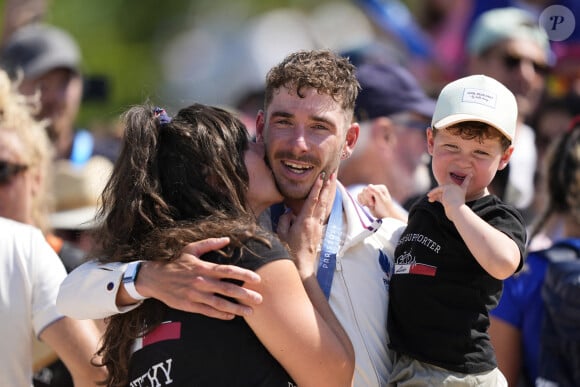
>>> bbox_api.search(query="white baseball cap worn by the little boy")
[431,75,518,142]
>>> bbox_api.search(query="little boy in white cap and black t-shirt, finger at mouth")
[361,75,526,387]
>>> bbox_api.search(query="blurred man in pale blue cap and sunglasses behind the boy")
[466,7,552,221]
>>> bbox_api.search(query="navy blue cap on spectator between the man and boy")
[355,61,435,120]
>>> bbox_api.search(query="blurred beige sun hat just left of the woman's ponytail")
[50,156,113,230]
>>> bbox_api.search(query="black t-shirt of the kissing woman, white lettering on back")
[129,238,295,387]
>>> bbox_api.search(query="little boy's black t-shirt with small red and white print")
[388,195,526,373]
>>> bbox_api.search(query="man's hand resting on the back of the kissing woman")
[136,238,262,320]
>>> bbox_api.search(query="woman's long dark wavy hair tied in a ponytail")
[91,104,268,386]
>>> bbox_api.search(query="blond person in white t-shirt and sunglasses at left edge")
[0,71,106,386]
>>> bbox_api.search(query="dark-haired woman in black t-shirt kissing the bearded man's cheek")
[93,104,354,387]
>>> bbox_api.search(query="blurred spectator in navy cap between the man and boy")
[339,61,435,212]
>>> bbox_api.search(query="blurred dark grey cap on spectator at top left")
[0,23,81,78]
